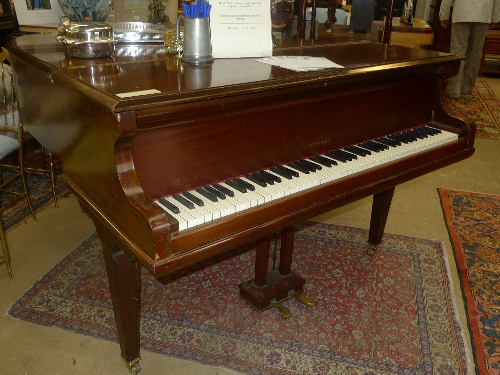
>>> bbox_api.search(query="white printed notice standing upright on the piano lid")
[210,0,273,58]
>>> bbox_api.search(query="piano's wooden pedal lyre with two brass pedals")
[238,228,314,319]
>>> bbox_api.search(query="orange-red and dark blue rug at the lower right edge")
[438,189,500,375]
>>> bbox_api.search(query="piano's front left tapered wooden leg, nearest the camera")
[87,214,141,374]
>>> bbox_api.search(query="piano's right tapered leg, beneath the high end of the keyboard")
[368,188,394,256]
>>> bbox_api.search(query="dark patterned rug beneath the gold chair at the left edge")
[1,171,69,232]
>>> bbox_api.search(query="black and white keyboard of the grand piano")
[154,126,458,231]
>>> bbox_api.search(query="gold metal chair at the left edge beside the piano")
[0,48,57,280]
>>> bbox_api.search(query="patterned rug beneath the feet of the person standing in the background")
[448,79,500,139]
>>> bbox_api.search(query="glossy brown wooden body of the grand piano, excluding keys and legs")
[8,35,474,277]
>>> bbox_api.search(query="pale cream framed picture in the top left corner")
[14,0,64,27]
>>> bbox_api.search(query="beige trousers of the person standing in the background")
[446,22,489,98]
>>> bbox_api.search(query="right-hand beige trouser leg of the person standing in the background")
[460,22,489,95]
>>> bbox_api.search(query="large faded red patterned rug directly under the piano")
[9,223,473,375]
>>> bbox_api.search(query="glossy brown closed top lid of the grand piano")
[13,34,456,101]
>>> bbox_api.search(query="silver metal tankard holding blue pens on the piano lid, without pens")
[176,16,214,64]
